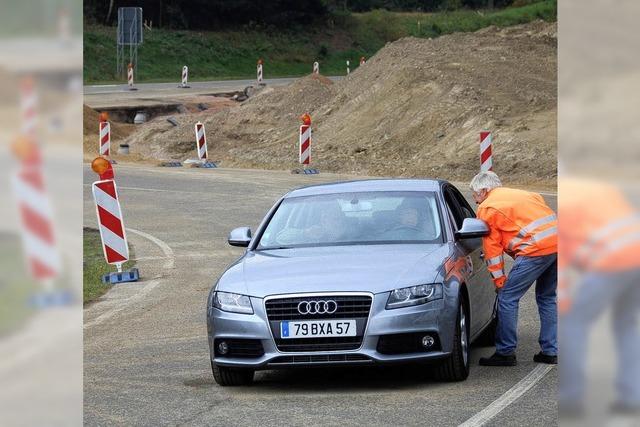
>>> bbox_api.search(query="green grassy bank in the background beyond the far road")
[84,0,557,84]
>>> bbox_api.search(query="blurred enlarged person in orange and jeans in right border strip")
[558,178,640,414]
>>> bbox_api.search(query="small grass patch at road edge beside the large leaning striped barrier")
[82,227,135,304]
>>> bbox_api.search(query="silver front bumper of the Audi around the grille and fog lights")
[207,293,457,370]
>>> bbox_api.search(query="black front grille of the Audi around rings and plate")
[265,294,372,352]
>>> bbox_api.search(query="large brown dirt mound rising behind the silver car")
[129,21,557,185]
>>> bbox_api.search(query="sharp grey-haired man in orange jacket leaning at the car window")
[470,171,558,366]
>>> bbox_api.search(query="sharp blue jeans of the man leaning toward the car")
[496,254,558,356]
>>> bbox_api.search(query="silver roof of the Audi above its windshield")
[285,179,446,198]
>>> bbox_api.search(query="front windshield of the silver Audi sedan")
[257,191,442,250]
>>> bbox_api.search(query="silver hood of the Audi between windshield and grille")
[217,244,449,298]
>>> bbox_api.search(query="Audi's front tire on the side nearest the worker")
[435,297,469,382]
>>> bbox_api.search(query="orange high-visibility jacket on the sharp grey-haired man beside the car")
[478,187,558,288]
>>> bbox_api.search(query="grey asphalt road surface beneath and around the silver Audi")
[84,165,557,426]
